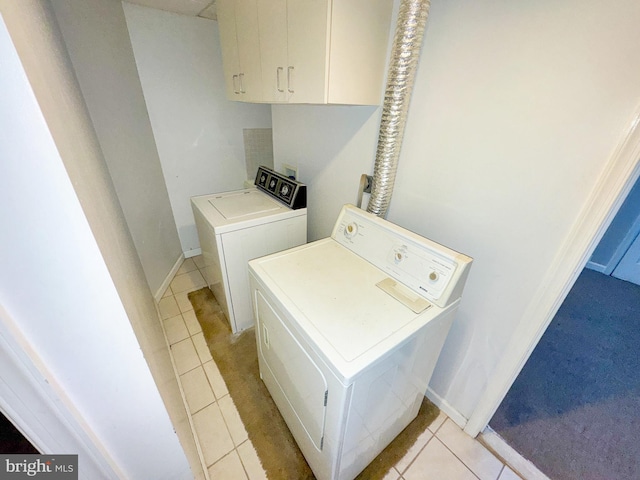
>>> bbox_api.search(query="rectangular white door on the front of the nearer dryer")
[255,291,327,450]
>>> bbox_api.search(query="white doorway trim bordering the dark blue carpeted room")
[464,105,640,437]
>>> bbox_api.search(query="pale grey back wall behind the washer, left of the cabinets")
[123,3,271,256]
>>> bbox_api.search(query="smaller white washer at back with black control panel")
[191,167,307,333]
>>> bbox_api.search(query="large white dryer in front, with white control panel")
[249,205,472,480]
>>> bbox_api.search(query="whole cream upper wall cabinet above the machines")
[218,0,393,105]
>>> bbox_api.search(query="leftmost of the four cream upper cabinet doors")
[216,0,240,100]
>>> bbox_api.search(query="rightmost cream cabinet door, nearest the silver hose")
[285,0,331,103]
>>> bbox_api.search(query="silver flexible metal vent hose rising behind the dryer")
[367,0,431,217]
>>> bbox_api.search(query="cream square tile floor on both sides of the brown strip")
[158,257,520,480]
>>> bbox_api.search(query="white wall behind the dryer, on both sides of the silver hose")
[273,0,640,418]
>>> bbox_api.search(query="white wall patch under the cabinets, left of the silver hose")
[271,105,380,240]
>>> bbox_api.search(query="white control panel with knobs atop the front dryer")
[331,205,472,307]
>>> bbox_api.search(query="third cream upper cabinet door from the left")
[258,0,289,103]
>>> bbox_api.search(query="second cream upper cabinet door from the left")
[235,0,262,102]
